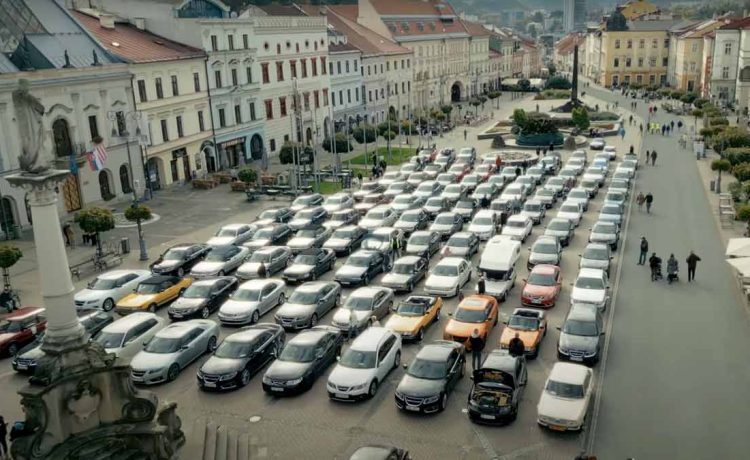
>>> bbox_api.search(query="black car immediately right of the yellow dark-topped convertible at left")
[167,276,237,321]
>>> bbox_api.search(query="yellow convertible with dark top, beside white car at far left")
[115,275,193,315]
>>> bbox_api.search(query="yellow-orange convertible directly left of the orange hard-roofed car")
[385,295,443,340]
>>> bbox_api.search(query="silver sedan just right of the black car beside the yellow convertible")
[219,279,286,326]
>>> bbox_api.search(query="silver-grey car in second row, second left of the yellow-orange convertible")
[274,281,341,329]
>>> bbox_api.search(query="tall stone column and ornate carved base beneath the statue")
[6,170,185,460]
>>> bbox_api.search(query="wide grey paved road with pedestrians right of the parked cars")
[587,82,750,459]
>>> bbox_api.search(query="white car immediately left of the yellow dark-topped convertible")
[73,270,151,311]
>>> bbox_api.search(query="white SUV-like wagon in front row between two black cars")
[326,327,401,401]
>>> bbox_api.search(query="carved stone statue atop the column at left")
[13,79,49,174]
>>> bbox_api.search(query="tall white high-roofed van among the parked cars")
[479,235,521,301]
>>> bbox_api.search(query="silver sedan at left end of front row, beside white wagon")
[130,319,219,385]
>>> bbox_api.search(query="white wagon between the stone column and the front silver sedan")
[95,312,166,362]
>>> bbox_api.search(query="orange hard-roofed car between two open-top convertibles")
[443,295,498,350]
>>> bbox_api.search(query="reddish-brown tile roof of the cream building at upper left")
[72,11,206,63]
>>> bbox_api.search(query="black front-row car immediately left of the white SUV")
[263,326,344,395]
